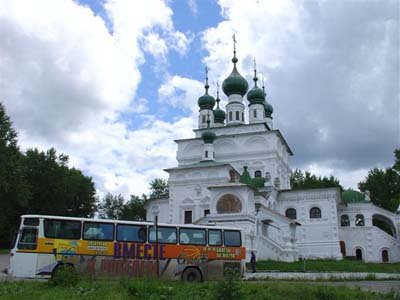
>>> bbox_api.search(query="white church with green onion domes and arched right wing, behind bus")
[146,42,400,262]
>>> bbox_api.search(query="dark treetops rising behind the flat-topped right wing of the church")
[290,169,343,190]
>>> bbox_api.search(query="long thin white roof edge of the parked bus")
[21,215,242,231]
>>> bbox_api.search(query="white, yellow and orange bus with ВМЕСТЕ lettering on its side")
[9,215,246,281]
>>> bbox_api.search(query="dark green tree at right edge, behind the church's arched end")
[358,148,400,211]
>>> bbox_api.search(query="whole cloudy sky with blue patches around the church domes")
[0,0,400,198]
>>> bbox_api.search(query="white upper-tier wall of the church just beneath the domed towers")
[176,129,291,189]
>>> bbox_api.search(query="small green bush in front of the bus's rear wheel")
[214,272,244,300]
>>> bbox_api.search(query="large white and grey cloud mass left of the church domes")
[0,0,191,196]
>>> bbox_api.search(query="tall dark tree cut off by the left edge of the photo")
[0,102,31,247]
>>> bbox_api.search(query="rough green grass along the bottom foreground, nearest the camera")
[0,279,400,300]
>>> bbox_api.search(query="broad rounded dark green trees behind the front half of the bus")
[25,148,97,217]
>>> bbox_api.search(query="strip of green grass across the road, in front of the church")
[247,259,400,273]
